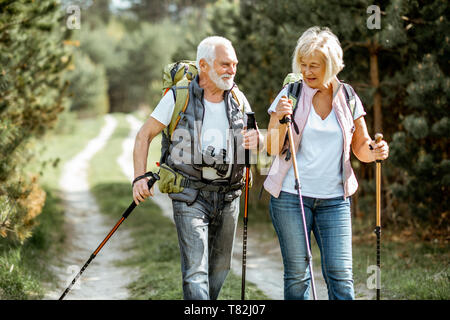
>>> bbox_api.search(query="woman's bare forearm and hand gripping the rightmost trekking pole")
[352,117,389,162]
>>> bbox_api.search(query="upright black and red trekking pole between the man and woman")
[241,112,256,300]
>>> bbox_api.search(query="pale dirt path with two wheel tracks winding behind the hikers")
[46,115,370,300]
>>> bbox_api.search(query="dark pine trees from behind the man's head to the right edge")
[204,0,450,232]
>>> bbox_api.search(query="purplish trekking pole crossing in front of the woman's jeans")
[283,112,317,300]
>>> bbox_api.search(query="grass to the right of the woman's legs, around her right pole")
[353,219,450,300]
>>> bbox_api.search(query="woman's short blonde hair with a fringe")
[292,26,344,86]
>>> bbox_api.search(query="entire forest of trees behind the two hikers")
[0,0,450,300]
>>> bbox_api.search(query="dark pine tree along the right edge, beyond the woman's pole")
[391,1,450,237]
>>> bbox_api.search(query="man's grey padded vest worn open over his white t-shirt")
[159,76,245,202]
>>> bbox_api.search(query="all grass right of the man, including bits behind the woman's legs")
[244,181,450,300]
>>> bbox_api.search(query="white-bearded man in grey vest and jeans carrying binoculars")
[133,36,262,300]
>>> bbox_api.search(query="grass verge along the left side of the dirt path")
[0,114,101,300]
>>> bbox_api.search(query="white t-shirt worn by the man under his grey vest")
[150,90,251,180]
